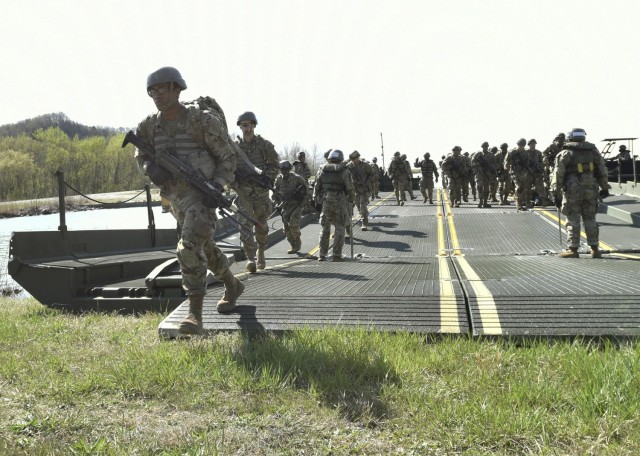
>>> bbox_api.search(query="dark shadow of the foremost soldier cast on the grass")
[236,328,400,427]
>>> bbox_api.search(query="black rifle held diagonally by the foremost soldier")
[122,130,262,231]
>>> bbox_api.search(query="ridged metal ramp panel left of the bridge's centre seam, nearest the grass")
[159,259,469,337]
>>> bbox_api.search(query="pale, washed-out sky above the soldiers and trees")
[0,0,640,166]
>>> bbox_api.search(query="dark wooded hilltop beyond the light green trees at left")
[0,112,125,139]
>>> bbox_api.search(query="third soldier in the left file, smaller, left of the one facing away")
[273,160,307,254]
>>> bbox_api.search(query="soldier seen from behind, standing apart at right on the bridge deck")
[551,128,611,258]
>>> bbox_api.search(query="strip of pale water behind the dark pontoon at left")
[0,206,176,296]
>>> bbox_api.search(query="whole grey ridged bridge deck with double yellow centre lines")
[159,191,640,337]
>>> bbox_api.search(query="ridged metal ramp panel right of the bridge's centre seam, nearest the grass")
[458,256,640,336]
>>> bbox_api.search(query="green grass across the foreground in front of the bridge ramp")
[0,298,640,455]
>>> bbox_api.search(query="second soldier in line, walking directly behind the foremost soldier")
[234,111,278,273]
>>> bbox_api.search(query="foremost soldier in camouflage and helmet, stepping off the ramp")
[136,67,244,334]
